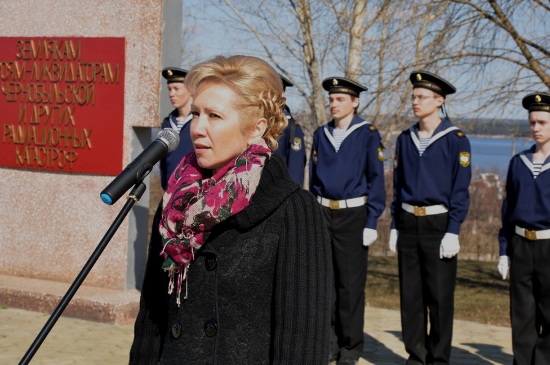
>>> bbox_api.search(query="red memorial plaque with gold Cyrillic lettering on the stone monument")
[0,37,125,175]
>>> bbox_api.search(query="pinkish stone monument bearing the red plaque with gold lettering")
[0,0,182,323]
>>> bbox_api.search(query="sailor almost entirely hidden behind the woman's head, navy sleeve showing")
[275,75,306,186]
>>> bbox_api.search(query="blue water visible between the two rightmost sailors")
[468,137,534,178]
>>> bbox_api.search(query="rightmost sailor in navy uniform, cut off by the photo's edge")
[498,93,550,365]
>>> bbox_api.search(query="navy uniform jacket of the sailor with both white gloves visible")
[391,120,472,234]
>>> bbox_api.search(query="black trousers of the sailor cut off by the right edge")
[509,235,550,365]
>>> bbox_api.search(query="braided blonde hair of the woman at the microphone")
[185,55,288,150]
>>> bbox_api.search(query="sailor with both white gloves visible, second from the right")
[389,71,471,364]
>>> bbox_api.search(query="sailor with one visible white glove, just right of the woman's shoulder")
[309,77,386,364]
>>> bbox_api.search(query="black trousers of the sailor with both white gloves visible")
[397,211,457,364]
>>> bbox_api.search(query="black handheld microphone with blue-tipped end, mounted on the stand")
[100,128,180,205]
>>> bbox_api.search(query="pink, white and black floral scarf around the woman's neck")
[159,140,271,306]
